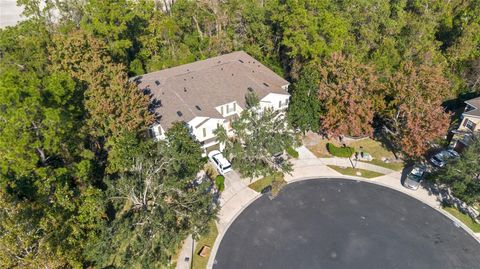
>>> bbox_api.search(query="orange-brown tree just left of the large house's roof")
[49,31,154,172]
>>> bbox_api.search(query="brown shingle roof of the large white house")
[132,51,289,129]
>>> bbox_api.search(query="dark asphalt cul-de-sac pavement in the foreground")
[213,179,480,269]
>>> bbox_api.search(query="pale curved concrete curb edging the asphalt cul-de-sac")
[207,176,480,269]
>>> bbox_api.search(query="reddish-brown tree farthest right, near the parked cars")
[384,62,450,158]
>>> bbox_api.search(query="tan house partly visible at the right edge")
[450,97,480,151]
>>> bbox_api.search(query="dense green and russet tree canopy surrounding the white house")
[0,0,480,268]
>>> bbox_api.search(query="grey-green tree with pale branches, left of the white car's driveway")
[87,129,217,268]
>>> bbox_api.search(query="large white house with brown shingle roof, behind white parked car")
[133,51,290,153]
